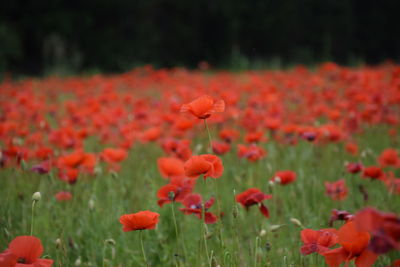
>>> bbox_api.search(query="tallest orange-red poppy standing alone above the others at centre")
[181,95,225,119]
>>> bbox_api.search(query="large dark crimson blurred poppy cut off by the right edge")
[354,208,400,254]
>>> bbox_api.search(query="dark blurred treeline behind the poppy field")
[0,0,400,75]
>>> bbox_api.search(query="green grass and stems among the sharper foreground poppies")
[0,126,400,267]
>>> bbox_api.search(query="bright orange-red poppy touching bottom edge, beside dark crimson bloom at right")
[322,221,378,267]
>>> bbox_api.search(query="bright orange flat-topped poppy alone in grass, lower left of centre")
[119,210,160,232]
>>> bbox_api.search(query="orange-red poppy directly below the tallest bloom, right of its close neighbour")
[184,154,224,179]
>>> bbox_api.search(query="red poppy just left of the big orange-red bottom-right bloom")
[300,228,338,255]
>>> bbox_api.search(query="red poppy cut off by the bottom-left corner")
[0,236,53,267]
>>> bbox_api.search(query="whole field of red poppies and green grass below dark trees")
[0,63,400,267]
